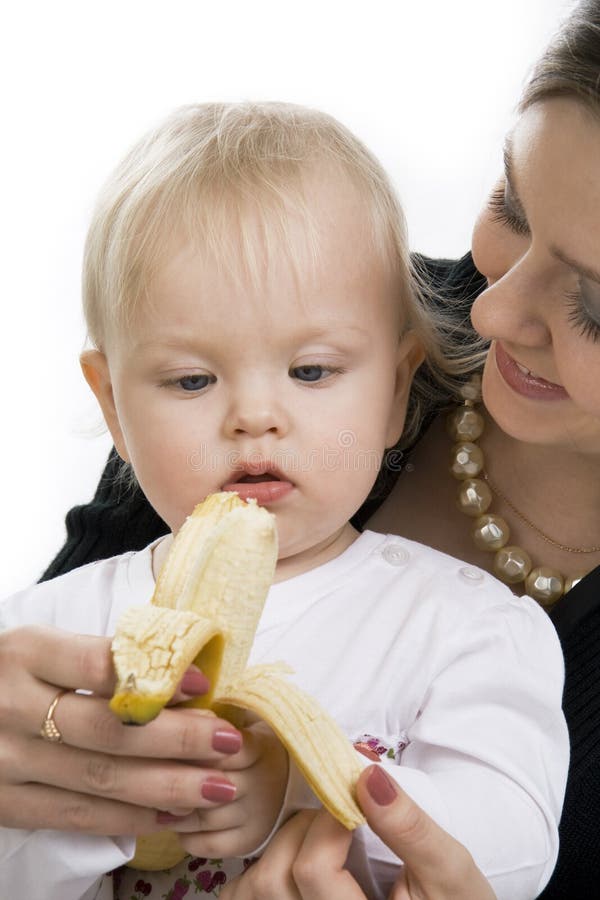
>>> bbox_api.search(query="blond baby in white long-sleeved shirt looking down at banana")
[0,103,568,900]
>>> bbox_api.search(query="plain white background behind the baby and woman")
[0,0,567,600]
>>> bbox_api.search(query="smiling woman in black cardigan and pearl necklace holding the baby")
[0,0,600,900]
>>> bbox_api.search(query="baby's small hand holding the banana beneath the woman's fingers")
[168,722,289,859]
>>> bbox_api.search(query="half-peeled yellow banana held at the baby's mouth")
[110,492,365,870]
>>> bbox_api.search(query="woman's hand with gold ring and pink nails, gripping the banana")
[0,627,242,835]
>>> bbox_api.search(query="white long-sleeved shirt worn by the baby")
[0,531,568,900]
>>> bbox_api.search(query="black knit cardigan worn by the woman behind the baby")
[41,254,600,900]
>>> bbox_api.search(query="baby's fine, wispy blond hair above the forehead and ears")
[83,103,478,448]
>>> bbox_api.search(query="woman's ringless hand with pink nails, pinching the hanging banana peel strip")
[220,765,495,900]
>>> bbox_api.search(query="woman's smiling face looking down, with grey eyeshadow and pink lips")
[472,98,600,454]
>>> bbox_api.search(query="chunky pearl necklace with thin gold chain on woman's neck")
[446,380,588,608]
